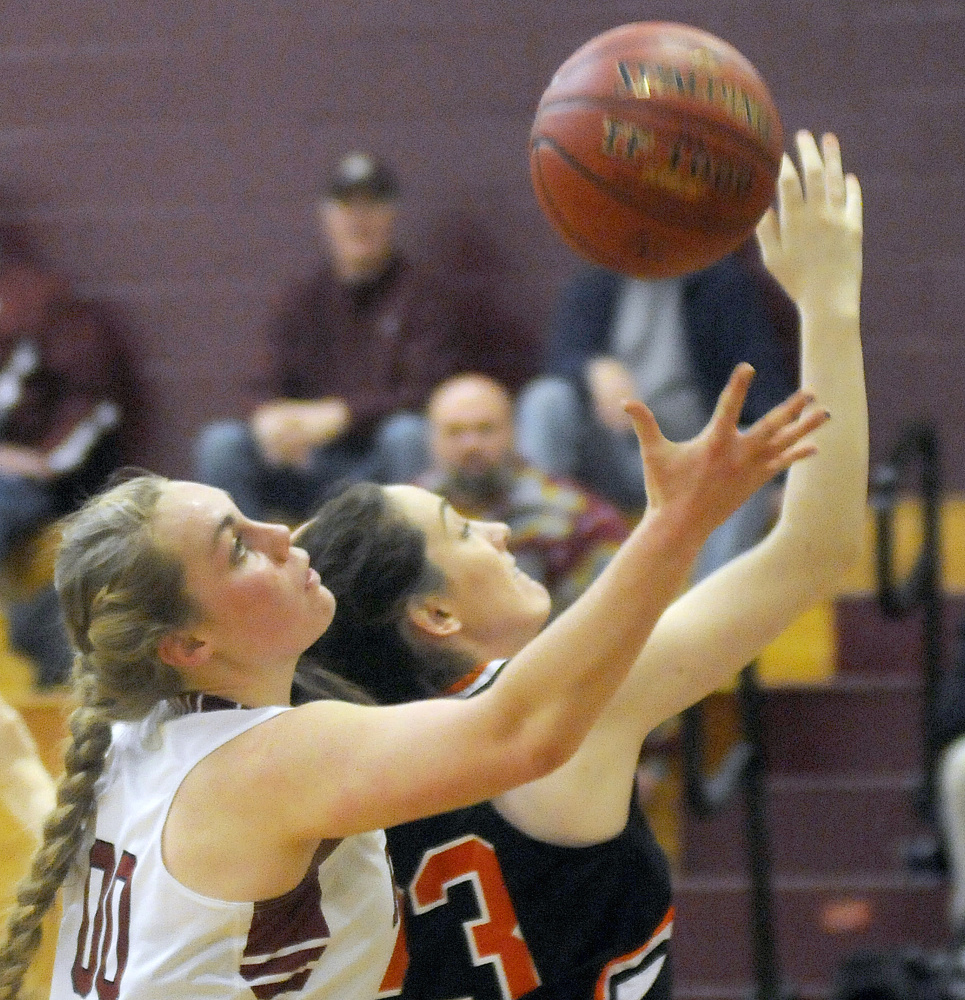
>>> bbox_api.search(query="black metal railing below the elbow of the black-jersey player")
[681,663,789,1000]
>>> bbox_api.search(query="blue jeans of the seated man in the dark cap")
[194,413,428,520]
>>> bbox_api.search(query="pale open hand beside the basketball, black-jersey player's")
[757,131,862,312]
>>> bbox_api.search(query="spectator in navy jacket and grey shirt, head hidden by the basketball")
[517,245,794,579]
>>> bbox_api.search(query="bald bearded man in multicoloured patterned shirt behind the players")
[419,374,629,614]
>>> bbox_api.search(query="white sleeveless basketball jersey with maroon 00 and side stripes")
[51,696,398,1000]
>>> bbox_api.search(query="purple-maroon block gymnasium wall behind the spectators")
[0,0,965,489]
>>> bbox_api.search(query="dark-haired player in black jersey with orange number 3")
[299,133,868,1000]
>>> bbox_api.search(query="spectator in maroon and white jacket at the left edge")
[0,206,141,685]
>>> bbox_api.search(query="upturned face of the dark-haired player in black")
[385,486,550,657]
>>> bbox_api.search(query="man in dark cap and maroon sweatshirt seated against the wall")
[195,153,532,519]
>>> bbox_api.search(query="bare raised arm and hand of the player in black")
[499,134,868,843]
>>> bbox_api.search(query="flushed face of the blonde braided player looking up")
[154,482,335,665]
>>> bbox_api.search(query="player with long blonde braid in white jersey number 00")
[0,292,812,1000]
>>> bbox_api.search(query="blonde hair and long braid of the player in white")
[0,475,196,1000]
